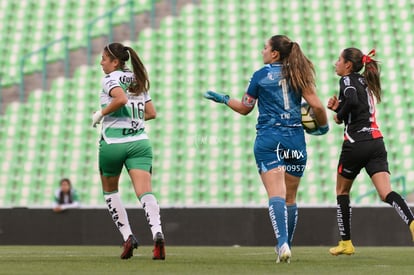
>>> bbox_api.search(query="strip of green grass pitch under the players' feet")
[0,246,414,275]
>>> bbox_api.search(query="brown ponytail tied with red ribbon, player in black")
[342,48,381,103]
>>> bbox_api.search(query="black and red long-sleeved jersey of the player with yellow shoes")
[336,73,382,142]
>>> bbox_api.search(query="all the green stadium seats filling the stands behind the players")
[0,0,414,207]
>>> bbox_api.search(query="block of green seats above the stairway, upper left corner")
[0,0,155,86]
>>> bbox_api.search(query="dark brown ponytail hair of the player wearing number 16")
[104,43,150,95]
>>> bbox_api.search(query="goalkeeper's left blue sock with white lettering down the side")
[269,197,288,247]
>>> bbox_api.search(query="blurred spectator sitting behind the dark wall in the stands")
[53,178,79,212]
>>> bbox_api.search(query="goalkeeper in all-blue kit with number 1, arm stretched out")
[204,35,329,263]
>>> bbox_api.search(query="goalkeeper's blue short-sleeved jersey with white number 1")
[246,62,302,130]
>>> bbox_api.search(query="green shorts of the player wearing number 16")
[99,139,152,176]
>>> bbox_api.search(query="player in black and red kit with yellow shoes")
[327,48,414,256]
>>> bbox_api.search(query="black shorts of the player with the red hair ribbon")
[338,138,389,179]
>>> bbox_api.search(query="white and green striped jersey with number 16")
[100,70,151,144]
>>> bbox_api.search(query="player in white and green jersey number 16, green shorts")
[92,43,165,260]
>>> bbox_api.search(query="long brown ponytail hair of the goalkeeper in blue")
[269,35,315,91]
